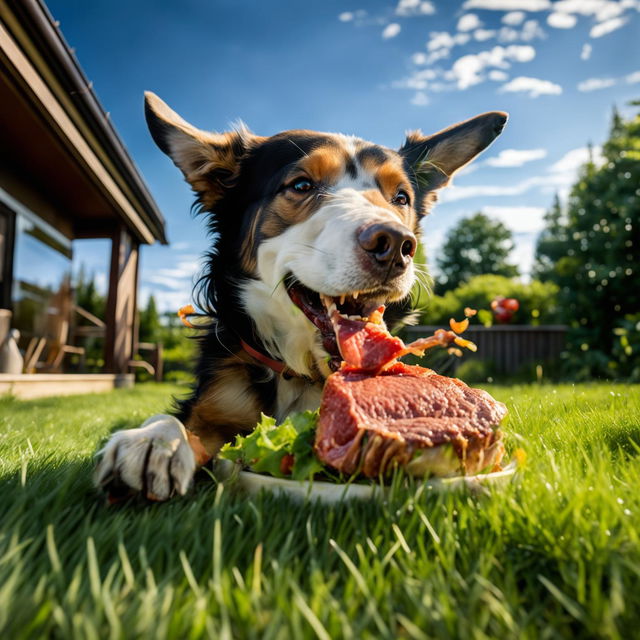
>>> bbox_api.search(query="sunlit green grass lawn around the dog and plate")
[0,384,640,640]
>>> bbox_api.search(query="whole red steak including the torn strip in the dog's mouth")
[315,316,507,477]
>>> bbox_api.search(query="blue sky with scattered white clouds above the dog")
[48,0,640,310]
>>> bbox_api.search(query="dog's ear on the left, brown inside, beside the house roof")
[144,91,263,207]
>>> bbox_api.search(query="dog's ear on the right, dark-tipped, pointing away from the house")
[399,111,509,214]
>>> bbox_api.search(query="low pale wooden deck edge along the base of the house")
[0,373,134,400]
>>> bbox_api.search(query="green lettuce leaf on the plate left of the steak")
[218,411,325,480]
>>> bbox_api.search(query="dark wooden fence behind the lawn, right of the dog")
[403,325,567,373]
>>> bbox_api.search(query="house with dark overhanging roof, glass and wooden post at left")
[0,0,167,396]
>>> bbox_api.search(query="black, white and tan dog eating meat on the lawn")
[96,92,508,501]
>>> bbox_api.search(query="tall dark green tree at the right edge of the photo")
[535,104,640,375]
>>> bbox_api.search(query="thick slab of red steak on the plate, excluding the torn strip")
[315,362,507,477]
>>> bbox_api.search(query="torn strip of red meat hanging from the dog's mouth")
[331,306,466,373]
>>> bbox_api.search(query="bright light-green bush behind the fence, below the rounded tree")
[418,275,558,326]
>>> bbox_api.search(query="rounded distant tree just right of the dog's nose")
[436,213,518,293]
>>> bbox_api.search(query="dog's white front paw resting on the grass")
[95,415,196,501]
